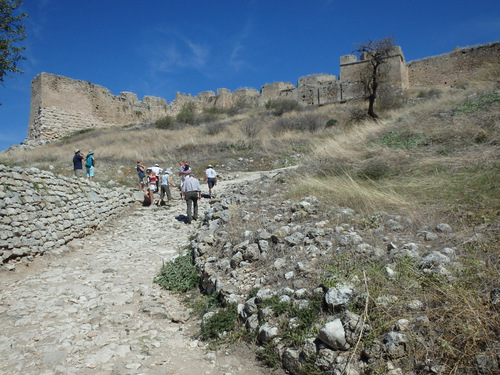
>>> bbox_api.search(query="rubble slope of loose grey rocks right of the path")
[188,171,498,375]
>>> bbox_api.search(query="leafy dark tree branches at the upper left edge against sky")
[0,0,28,84]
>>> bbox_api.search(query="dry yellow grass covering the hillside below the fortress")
[0,75,500,374]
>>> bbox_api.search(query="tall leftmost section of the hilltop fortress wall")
[27,73,168,142]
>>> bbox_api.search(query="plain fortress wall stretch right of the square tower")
[408,42,500,88]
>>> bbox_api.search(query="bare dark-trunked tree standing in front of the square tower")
[353,37,394,119]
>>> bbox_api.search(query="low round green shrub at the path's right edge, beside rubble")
[154,254,199,293]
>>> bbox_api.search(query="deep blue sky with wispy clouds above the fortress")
[0,0,500,150]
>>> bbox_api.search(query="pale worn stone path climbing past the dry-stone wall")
[0,174,270,375]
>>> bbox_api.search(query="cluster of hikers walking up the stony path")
[136,160,217,224]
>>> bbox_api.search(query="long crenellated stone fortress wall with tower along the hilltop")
[25,42,500,144]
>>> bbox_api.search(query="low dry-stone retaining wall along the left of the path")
[0,164,133,265]
